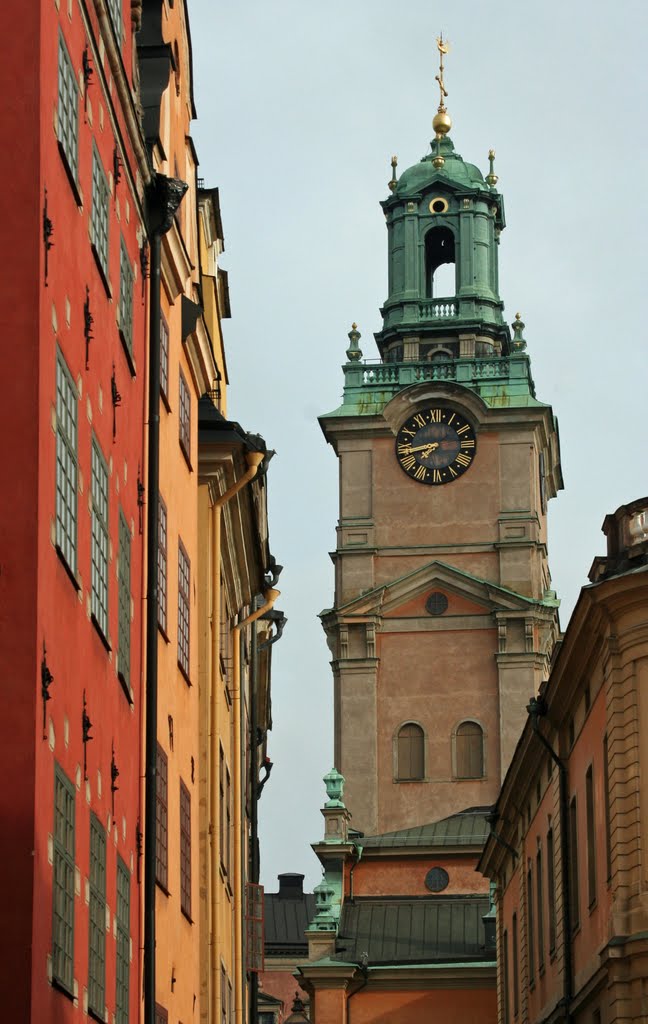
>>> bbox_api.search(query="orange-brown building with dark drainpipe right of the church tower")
[480,499,648,1024]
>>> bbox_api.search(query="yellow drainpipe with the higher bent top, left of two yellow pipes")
[209,452,264,1024]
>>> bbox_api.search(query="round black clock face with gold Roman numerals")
[396,406,477,484]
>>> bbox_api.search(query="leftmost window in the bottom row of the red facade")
[52,765,75,995]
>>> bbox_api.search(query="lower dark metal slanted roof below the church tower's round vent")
[334,896,489,967]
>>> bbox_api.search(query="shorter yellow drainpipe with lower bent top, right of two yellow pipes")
[231,587,279,1024]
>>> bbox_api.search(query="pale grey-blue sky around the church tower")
[188,0,648,891]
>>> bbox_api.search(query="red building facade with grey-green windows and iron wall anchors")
[0,0,147,1024]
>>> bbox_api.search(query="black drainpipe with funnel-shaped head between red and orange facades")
[143,174,187,1024]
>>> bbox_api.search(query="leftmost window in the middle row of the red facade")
[56,351,78,574]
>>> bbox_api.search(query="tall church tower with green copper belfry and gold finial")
[319,40,562,834]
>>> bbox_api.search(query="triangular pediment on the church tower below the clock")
[327,559,536,620]
